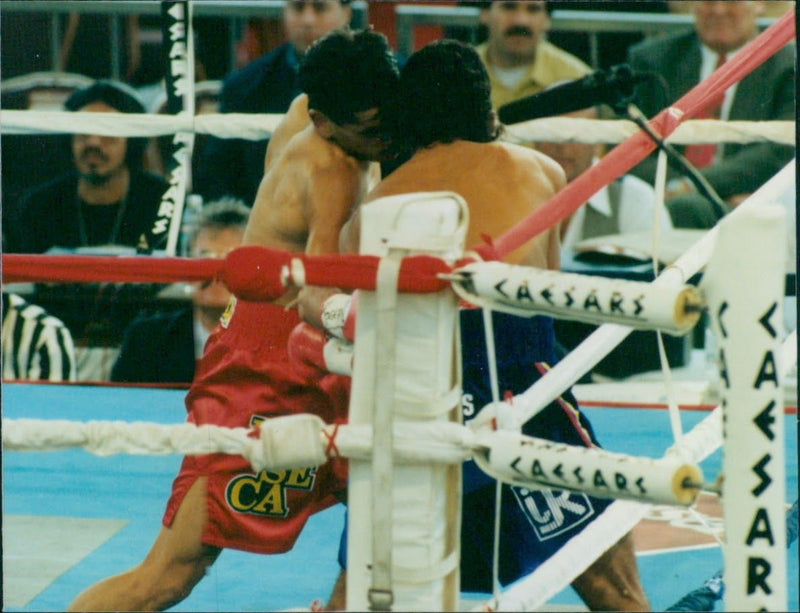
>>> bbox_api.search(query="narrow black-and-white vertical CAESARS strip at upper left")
[138,0,194,256]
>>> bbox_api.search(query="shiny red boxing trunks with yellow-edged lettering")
[163,300,350,553]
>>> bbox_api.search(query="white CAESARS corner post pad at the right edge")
[703,205,787,611]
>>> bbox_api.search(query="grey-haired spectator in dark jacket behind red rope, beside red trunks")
[111,198,250,384]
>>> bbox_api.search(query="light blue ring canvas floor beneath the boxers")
[2,383,800,611]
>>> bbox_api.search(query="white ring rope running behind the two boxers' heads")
[0,110,795,145]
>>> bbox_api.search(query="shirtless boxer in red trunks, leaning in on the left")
[70,31,397,611]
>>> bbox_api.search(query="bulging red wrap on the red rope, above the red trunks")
[221,246,292,302]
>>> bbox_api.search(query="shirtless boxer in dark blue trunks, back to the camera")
[332,41,649,611]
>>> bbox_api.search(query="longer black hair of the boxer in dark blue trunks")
[392,39,499,158]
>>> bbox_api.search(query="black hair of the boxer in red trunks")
[299,29,399,124]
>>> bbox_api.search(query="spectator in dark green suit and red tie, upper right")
[629,1,796,228]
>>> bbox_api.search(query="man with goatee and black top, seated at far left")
[3,81,169,381]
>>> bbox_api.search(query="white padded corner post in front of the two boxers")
[347,192,468,611]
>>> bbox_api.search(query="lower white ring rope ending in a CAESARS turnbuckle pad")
[3,414,701,505]
